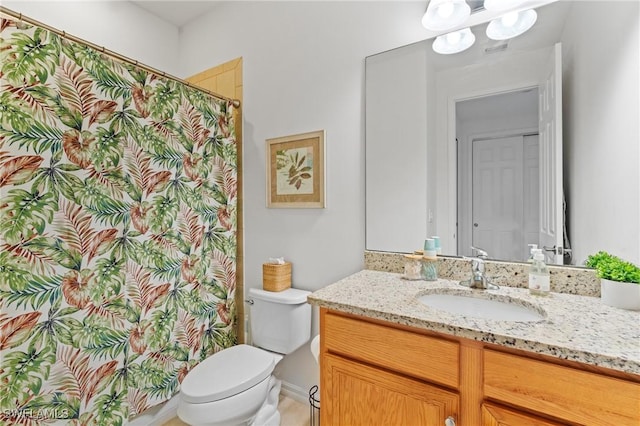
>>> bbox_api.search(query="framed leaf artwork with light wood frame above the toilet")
[266,130,325,208]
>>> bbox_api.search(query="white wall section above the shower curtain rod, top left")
[2,0,180,76]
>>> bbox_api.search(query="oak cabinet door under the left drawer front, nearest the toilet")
[320,354,459,426]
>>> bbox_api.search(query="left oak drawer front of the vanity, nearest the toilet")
[322,312,460,388]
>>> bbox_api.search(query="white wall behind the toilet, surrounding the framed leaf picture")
[180,1,426,400]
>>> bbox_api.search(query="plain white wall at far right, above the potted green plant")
[562,1,640,264]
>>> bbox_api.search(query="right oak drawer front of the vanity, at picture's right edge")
[483,349,640,426]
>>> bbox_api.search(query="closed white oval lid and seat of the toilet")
[180,344,276,404]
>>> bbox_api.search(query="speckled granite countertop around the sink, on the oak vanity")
[308,270,640,374]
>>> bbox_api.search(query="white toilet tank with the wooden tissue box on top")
[248,288,311,354]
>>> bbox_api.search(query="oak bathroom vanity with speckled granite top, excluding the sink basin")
[308,270,640,426]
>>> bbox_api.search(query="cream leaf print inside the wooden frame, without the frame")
[276,147,313,195]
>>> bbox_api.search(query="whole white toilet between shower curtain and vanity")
[178,288,311,426]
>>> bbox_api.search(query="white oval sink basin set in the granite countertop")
[418,293,545,322]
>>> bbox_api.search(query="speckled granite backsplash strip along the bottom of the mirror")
[364,251,600,297]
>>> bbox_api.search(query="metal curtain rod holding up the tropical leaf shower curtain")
[0,6,240,108]
